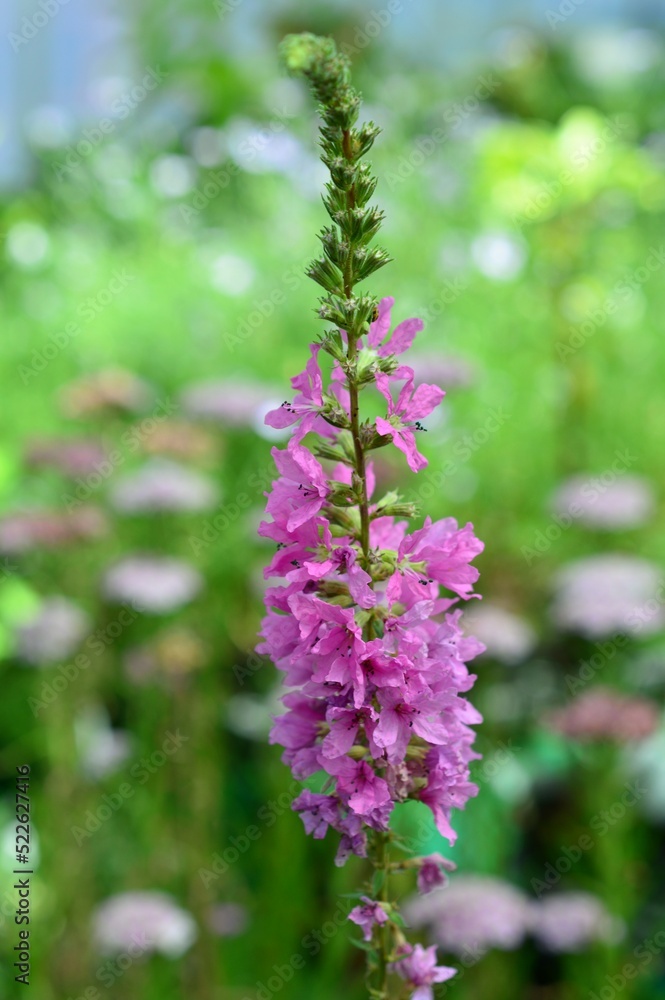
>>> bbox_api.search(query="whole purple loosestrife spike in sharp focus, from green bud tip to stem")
[258,35,484,1000]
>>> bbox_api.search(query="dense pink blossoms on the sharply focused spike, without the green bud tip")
[258,299,483,864]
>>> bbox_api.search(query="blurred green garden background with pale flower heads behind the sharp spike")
[0,0,665,1000]
